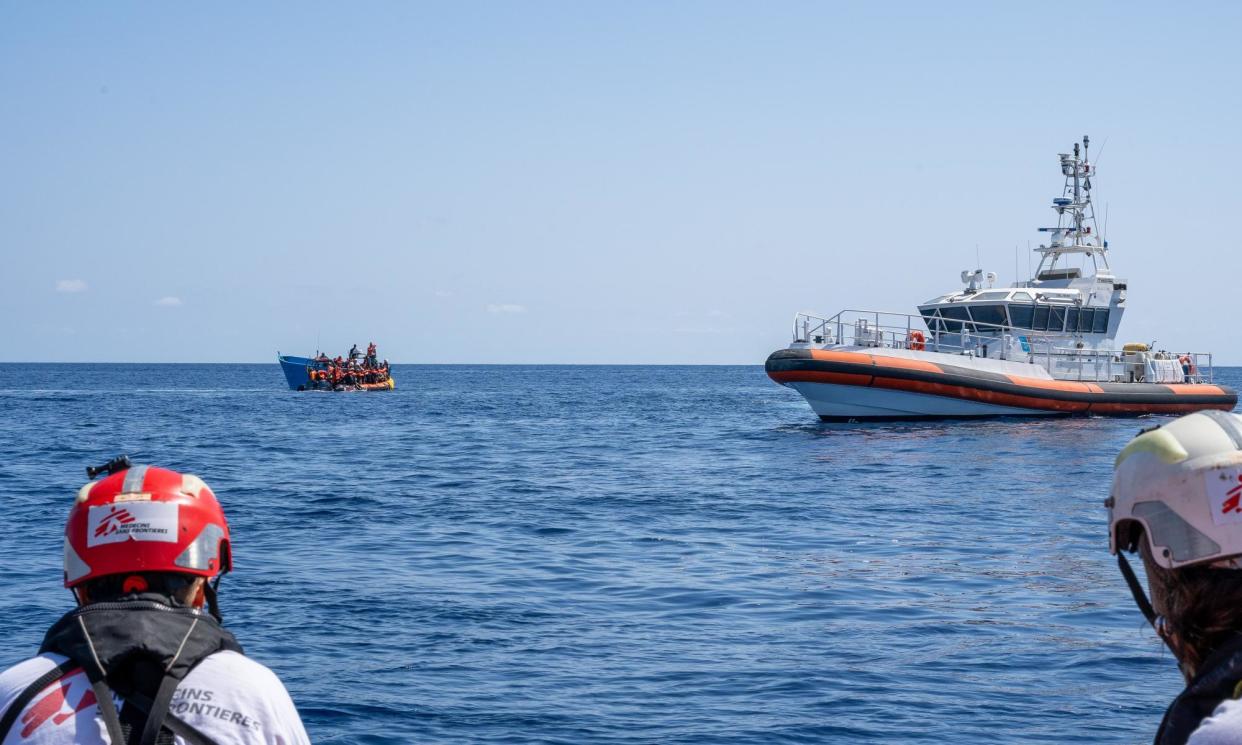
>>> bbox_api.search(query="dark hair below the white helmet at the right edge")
[1139,540,1242,674]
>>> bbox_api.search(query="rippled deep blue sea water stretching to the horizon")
[0,365,1242,744]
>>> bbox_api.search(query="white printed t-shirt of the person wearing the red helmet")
[0,652,311,745]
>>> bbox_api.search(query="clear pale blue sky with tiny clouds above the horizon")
[0,1,1242,364]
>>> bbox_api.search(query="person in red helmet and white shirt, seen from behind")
[0,457,309,745]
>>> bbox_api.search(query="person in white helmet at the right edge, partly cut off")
[1105,411,1242,745]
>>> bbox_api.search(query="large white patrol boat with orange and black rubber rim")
[766,137,1237,421]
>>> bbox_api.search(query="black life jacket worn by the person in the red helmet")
[0,594,242,745]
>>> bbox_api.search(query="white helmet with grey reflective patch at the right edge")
[1105,411,1242,569]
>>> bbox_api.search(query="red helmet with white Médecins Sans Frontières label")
[65,466,232,587]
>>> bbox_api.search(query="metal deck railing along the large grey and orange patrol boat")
[794,309,1213,382]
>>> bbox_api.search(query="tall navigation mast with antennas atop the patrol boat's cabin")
[1033,137,1108,279]
